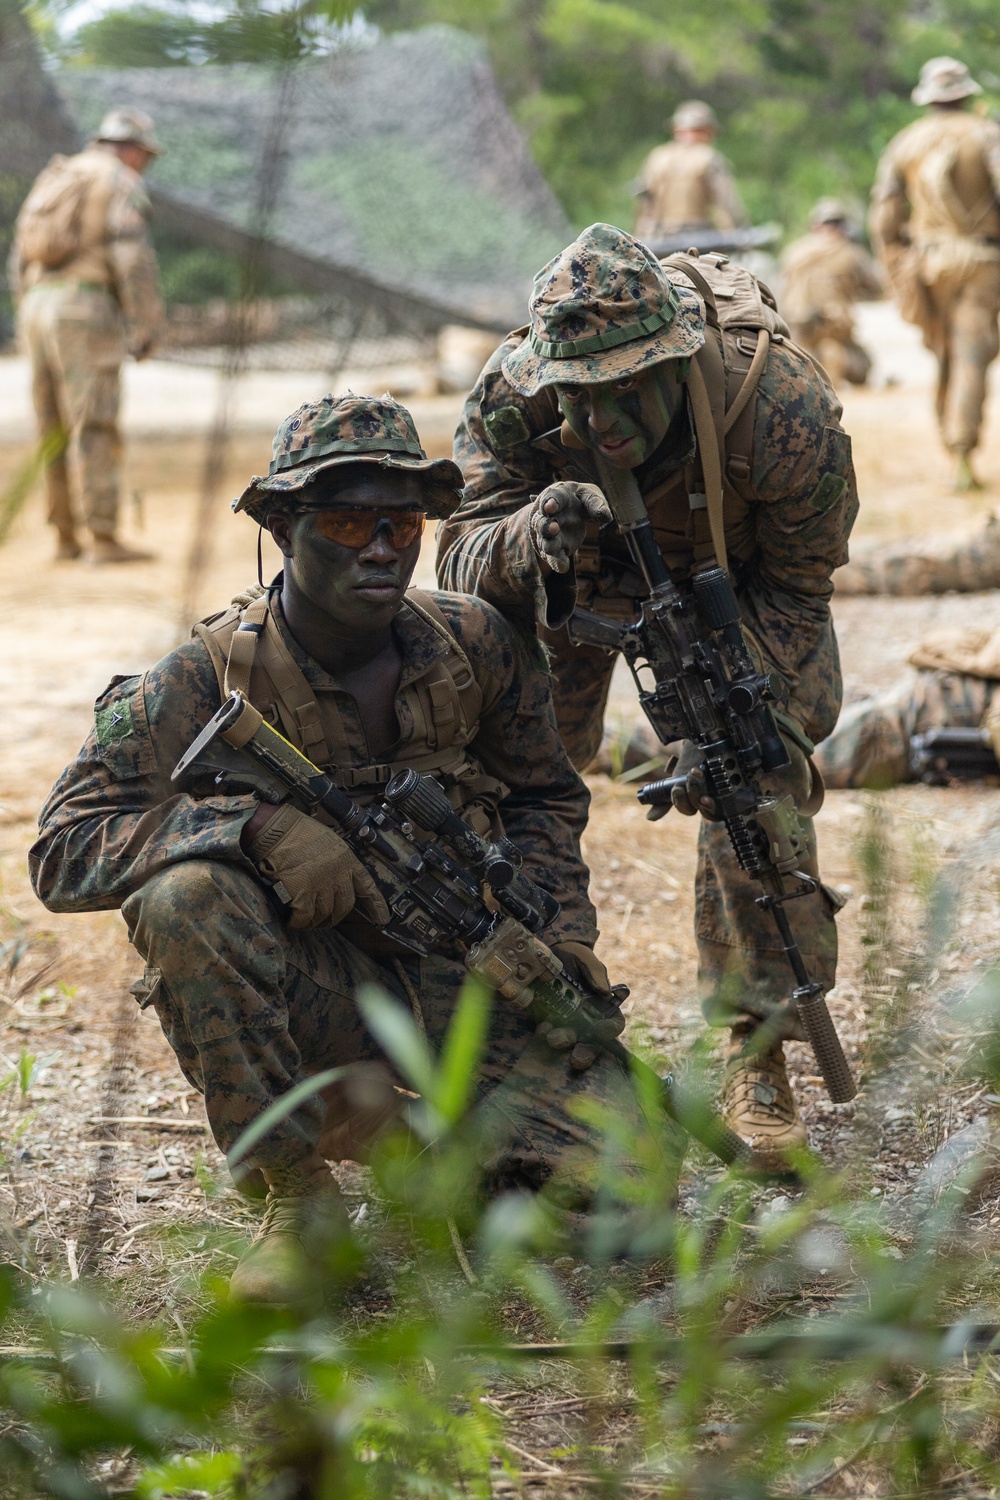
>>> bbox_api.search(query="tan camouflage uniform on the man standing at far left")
[10,111,163,555]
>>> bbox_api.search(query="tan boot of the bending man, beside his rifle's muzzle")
[721,1029,808,1172]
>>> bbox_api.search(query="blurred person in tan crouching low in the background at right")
[781,198,882,386]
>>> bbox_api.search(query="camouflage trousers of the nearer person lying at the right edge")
[817,629,1000,788]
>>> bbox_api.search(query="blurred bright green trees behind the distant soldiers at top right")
[364,0,1000,230]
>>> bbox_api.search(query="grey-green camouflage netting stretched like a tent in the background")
[57,26,568,366]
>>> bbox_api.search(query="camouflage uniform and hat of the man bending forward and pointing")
[438,225,858,1035]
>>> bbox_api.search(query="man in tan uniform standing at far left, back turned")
[10,110,163,563]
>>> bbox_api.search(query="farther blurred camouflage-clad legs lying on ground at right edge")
[834,512,1000,596]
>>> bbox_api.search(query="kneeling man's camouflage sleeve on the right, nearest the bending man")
[436,594,597,945]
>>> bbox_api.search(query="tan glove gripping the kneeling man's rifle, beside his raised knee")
[247,803,388,927]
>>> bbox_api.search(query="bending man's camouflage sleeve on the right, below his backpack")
[739,347,858,723]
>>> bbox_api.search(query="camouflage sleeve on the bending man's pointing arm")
[438,335,576,633]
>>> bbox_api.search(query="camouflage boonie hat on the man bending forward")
[502,224,705,396]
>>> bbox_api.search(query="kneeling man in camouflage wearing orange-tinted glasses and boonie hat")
[31,396,680,1302]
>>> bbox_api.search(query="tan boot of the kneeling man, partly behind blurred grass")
[229,1163,349,1313]
